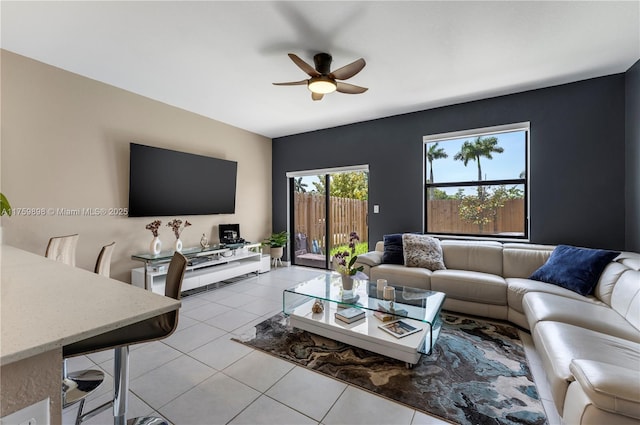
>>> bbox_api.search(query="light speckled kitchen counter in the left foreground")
[0,245,180,422]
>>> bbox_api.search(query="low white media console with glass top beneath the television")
[131,243,270,295]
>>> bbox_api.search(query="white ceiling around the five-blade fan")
[0,1,640,137]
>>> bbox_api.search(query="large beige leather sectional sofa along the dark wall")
[357,240,640,425]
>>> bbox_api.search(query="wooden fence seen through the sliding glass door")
[292,192,368,252]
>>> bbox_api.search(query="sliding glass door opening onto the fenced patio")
[289,167,369,269]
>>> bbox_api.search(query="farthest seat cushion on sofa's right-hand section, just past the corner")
[523,292,640,342]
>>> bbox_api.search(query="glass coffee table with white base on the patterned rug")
[282,273,445,367]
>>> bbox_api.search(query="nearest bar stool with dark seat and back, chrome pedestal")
[62,252,187,425]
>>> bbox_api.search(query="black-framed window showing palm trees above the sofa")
[424,123,529,239]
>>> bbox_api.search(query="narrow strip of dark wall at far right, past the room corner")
[625,60,640,252]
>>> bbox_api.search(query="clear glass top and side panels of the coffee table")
[282,273,446,354]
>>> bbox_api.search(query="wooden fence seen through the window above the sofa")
[427,199,525,235]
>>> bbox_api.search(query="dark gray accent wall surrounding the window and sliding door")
[272,74,625,249]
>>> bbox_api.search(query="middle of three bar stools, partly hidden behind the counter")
[62,242,116,423]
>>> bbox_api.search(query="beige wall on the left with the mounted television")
[0,50,271,282]
